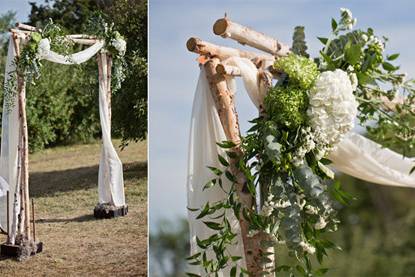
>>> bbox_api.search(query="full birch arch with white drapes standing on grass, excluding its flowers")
[0,23,128,256]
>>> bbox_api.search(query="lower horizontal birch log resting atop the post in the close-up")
[186,37,275,61]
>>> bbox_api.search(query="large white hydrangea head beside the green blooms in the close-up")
[307,69,357,154]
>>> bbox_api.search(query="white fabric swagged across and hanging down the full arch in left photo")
[0,34,125,237]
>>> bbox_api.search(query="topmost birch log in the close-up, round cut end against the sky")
[213,17,290,57]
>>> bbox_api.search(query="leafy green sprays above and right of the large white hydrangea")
[320,18,415,154]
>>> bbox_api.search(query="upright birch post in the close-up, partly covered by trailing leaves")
[204,58,269,277]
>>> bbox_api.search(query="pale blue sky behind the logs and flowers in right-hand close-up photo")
[148,0,415,231]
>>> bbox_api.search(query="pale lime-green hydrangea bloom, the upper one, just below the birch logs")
[274,53,319,89]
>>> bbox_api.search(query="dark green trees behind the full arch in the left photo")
[0,0,147,151]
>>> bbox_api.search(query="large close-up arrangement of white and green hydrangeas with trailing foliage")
[188,9,415,276]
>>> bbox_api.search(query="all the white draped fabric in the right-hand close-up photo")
[187,57,415,276]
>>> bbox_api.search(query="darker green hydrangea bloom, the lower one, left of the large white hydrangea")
[264,85,308,128]
